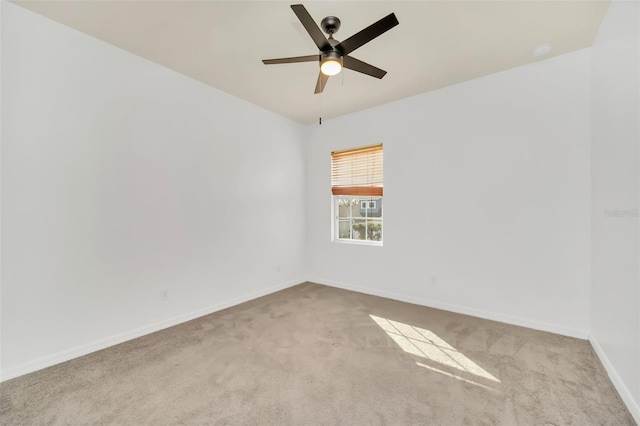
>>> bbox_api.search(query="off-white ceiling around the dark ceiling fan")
[14,0,609,124]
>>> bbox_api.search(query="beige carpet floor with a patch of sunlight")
[0,283,635,426]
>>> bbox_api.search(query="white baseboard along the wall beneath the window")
[307,276,589,340]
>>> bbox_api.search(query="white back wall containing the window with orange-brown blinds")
[307,49,590,338]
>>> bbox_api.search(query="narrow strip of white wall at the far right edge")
[591,1,640,423]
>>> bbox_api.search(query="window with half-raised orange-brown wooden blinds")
[331,144,383,245]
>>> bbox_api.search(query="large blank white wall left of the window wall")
[1,1,306,379]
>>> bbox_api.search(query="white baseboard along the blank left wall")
[0,280,304,382]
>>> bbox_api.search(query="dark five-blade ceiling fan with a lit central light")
[262,4,398,94]
